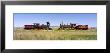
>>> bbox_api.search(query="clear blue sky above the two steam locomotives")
[13,13,97,27]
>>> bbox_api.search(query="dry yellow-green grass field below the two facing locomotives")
[13,28,97,40]
